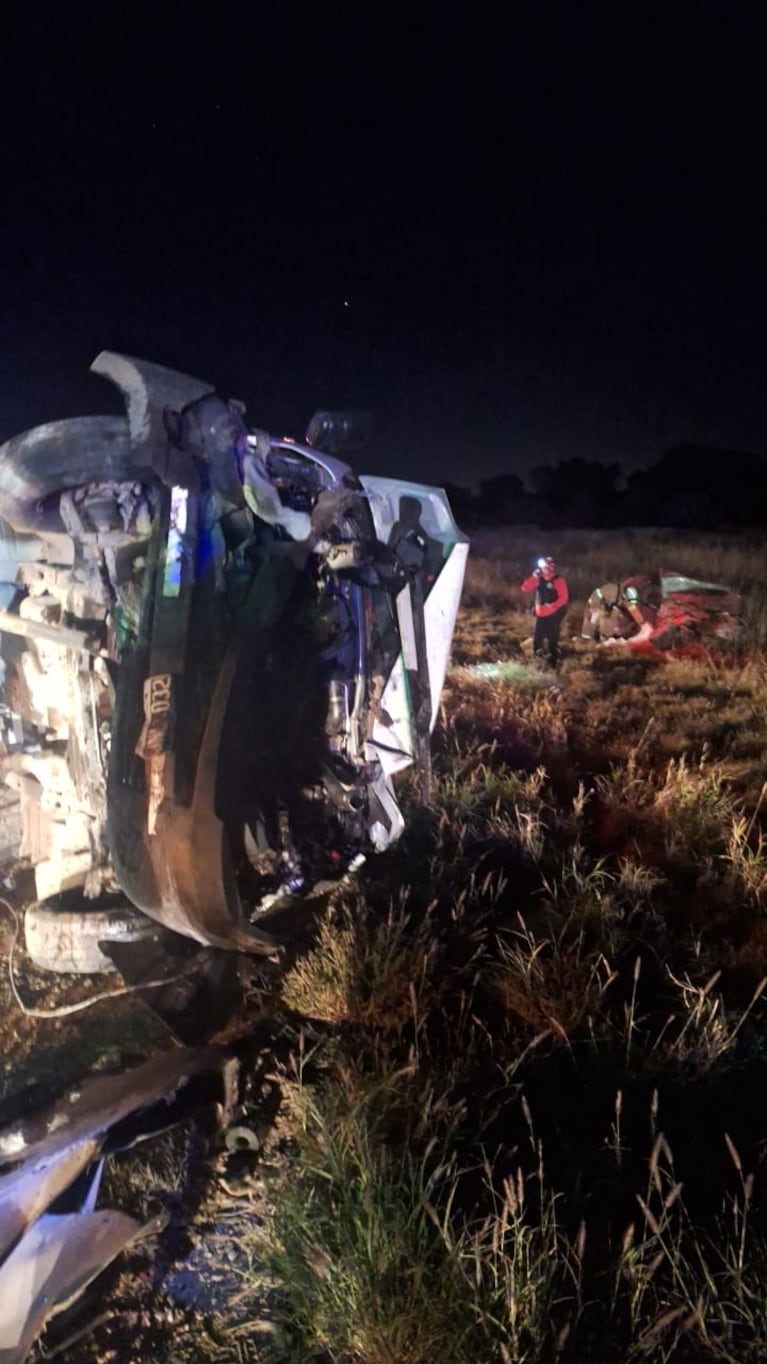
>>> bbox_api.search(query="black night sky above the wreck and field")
[0,0,767,484]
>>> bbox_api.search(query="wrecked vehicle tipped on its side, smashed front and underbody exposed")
[0,352,468,952]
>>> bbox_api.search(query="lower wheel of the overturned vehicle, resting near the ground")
[25,904,161,975]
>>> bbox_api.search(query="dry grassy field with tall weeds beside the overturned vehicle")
[4,531,767,1364]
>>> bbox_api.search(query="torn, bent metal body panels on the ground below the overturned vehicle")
[0,1046,239,1364]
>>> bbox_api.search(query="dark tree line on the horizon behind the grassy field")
[446,445,767,529]
